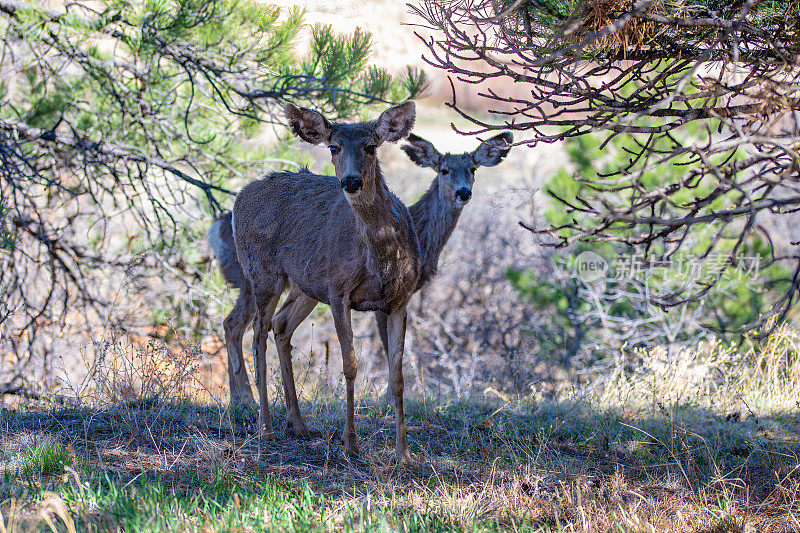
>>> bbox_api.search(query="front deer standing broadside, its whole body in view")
[216,101,422,463]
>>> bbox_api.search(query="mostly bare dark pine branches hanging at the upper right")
[414,0,800,327]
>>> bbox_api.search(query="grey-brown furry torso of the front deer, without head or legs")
[234,170,420,313]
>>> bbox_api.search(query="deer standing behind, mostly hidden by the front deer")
[210,133,513,442]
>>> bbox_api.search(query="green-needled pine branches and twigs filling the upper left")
[0,0,424,378]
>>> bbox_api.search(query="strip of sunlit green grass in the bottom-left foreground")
[28,473,482,531]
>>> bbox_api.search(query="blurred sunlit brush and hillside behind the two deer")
[0,0,794,412]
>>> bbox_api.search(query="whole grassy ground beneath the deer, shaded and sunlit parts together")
[0,328,800,533]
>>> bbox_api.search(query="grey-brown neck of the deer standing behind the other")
[409,177,463,288]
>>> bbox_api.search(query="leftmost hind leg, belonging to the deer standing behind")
[223,289,255,405]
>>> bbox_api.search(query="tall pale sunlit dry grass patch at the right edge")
[599,325,800,418]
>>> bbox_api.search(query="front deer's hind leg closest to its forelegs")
[272,288,317,437]
